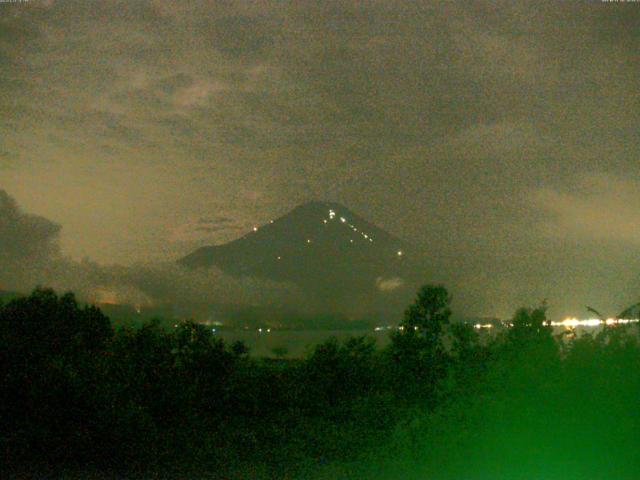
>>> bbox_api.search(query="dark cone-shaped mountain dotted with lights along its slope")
[178,201,424,311]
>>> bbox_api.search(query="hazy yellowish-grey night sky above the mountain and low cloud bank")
[0,0,640,315]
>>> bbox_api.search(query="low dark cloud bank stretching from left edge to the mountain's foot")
[0,190,306,314]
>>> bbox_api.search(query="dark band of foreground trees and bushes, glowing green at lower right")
[0,287,640,480]
